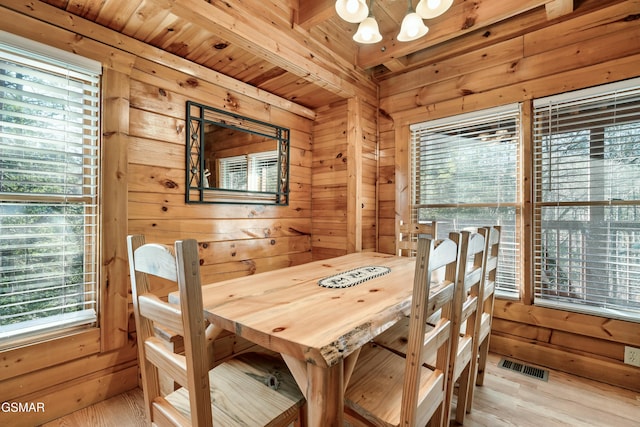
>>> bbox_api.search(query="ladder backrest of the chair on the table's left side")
[127,235,212,426]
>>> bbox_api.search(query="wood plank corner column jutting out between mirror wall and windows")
[311,98,378,259]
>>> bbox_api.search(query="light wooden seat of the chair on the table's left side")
[165,353,304,427]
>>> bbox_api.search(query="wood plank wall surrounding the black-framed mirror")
[128,76,312,282]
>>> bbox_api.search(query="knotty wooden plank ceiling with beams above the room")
[33,0,576,109]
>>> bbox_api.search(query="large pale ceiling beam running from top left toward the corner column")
[165,0,377,105]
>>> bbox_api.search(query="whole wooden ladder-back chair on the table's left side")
[127,235,304,427]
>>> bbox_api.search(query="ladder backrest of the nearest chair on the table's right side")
[400,238,459,425]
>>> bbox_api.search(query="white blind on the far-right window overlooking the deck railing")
[534,80,640,320]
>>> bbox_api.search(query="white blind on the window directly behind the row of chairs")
[411,105,521,296]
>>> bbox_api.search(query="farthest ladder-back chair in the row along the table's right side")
[467,226,501,413]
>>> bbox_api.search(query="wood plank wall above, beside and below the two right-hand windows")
[379,0,640,391]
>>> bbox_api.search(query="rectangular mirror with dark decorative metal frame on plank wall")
[186,101,289,205]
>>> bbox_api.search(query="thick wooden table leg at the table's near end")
[306,360,344,427]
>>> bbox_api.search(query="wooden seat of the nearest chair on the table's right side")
[345,343,444,426]
